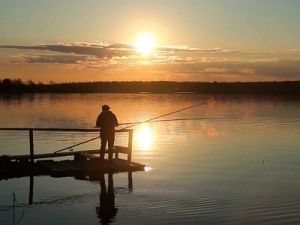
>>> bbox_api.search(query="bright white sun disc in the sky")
[133,33,156,55]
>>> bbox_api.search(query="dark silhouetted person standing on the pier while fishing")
[96,105,118,160]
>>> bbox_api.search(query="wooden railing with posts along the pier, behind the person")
[0,128,133,163]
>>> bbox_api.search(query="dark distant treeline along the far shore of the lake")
[0,79,300,95]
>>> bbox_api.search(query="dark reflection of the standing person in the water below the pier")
[96,174,118,224]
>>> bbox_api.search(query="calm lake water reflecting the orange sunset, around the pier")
[0,94,300,225]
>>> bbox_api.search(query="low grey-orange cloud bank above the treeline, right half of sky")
[141,60,300,81]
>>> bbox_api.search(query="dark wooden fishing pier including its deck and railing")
[0,128,145,180]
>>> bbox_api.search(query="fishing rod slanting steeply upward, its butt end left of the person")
[54,102,205,154]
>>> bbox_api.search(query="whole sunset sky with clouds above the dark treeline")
[0,0,300,83]
